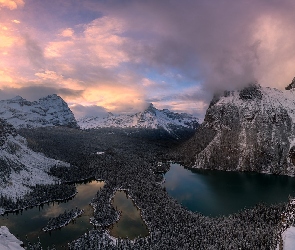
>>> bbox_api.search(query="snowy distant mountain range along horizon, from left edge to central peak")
[0,94,199,137]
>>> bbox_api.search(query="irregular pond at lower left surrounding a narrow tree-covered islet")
[0,181,104,249]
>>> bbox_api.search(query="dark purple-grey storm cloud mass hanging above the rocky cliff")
[98,0,295,96]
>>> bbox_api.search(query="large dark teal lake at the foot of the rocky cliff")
[163,164,295,216]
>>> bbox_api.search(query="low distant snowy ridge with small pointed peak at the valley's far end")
[78,104,198,133]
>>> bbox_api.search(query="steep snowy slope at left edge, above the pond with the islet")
[0,119,69,207]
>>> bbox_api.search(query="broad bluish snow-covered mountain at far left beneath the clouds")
[0,94,77,128]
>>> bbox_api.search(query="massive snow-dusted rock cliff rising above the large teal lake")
[182,85,295,175]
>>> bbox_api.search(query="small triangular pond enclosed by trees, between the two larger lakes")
[110,191,149,239]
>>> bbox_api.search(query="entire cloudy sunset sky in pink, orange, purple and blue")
[0,0,295,116]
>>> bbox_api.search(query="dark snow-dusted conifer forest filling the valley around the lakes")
[8,128,286,250]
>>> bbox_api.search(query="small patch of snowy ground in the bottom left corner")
[0,226,24,250]
